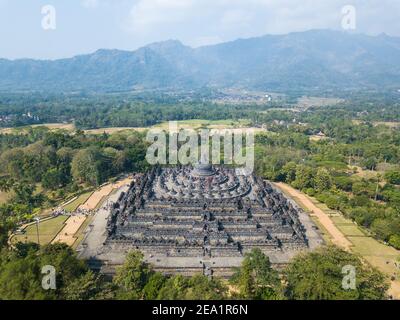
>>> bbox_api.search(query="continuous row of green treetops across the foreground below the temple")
[0,244,388,300]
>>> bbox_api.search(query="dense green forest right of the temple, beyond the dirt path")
[256,117,400,249]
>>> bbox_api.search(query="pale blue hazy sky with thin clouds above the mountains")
[0,0,400,59]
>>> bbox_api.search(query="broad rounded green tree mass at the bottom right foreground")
[285,246,389,300]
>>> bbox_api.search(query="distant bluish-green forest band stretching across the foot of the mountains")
[0,90,400,129]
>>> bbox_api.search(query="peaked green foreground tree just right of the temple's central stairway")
[231,249,282,300]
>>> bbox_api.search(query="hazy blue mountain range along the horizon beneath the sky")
[0,30,400,92]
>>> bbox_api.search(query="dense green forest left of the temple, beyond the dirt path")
[0,127,147,242]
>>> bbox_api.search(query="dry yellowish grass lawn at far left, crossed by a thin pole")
[11,216,68,245]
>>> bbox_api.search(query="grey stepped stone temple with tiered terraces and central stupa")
[86,164,322,277]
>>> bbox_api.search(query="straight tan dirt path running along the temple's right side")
[276,183,352,251]
